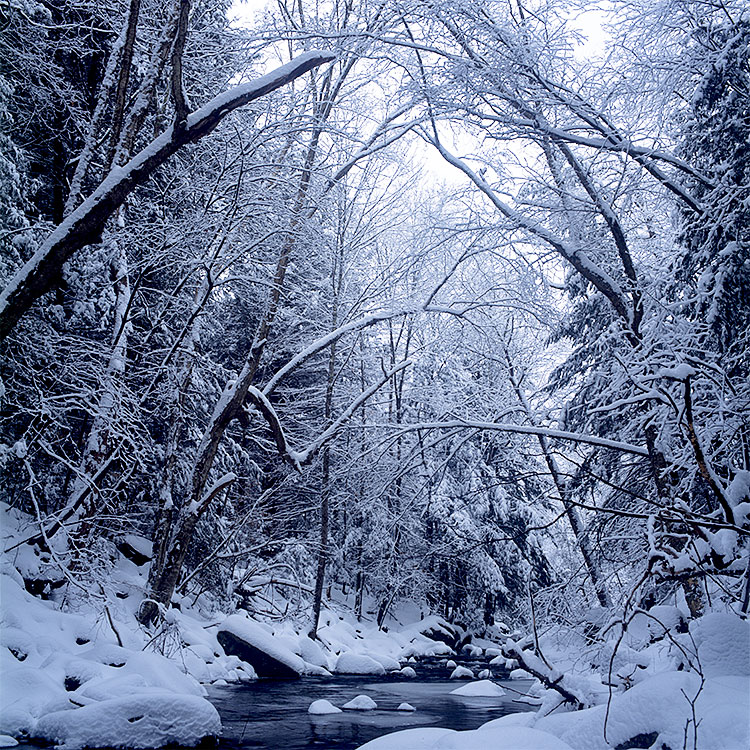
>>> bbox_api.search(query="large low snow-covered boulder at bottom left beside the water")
[33,693,221,750]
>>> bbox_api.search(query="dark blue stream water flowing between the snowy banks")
[208,669,531,750]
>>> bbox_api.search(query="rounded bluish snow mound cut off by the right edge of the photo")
[690,612,750,677]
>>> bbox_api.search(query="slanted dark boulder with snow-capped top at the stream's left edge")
[216,615,304,680]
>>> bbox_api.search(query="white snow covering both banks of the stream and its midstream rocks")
[0,506,750,750]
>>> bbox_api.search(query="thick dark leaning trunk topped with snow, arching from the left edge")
[0,50,336,339]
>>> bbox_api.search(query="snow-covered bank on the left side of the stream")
[0,504,470,750]
